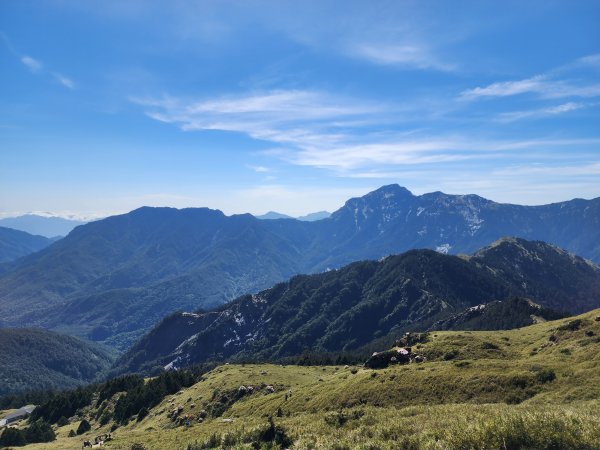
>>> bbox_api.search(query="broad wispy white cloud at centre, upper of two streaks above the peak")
[132,90,382,146]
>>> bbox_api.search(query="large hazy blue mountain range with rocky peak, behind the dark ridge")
[0,185,600,349]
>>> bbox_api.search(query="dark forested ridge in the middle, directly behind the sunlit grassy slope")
[117,239,600,371]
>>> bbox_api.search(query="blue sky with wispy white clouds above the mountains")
[0,0,600,217]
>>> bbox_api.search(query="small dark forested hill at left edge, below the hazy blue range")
[0,328,114,396]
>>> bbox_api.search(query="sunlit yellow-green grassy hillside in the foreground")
[8,310,600,450]
